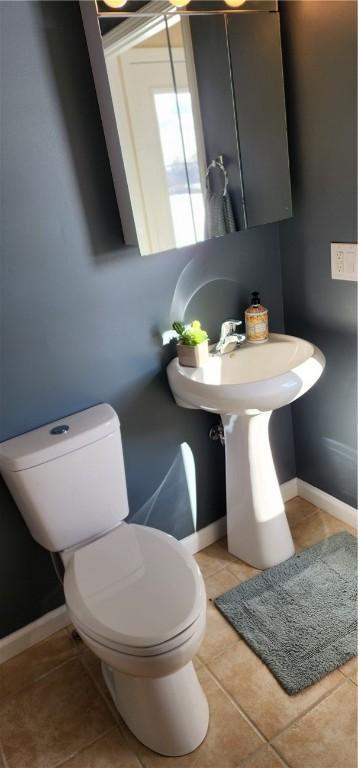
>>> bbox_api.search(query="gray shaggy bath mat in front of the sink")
[215,532,357,695]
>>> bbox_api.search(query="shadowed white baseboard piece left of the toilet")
[0,605,70,664]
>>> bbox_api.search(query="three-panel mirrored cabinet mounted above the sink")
[82,0,291,255]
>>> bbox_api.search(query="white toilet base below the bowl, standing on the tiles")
[102,662,209,757]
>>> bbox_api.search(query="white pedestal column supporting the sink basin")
[222,411,295,569]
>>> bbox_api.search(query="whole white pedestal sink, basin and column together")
[167,333,325,569]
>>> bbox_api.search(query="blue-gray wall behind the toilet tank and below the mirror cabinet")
[0,2,295,635]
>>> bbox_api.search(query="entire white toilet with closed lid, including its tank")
[0,404,209,756]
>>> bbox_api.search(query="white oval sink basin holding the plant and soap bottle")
[168,333,325,415]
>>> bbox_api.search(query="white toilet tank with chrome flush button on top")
[0,404,129,552]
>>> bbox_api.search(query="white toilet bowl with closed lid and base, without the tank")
[64,523,208,755]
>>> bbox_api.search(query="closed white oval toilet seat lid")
[64,523,204,648]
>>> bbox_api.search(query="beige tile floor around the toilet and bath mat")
[0,498,357,768]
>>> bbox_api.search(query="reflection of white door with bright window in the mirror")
[102,14,205,255]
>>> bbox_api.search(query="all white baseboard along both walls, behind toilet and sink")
[0,477,358,664]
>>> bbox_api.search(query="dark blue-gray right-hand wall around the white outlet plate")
[279,0,357,506]
